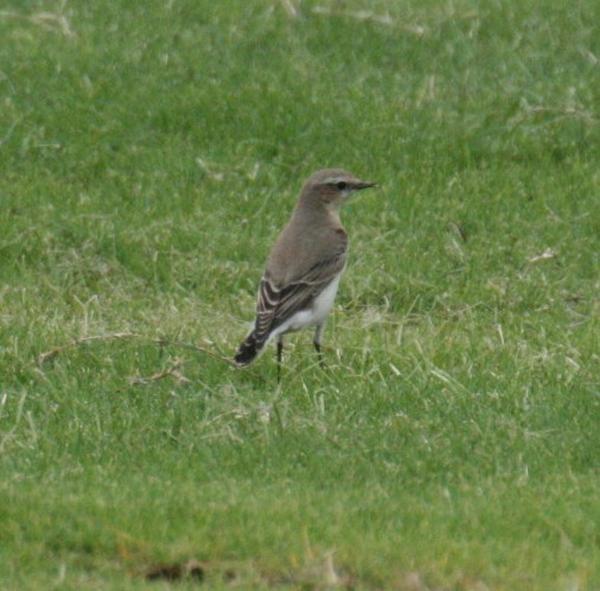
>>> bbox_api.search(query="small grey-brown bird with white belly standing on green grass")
[234,168,376,381]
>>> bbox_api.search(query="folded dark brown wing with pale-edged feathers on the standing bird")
[254,251,346,342]
